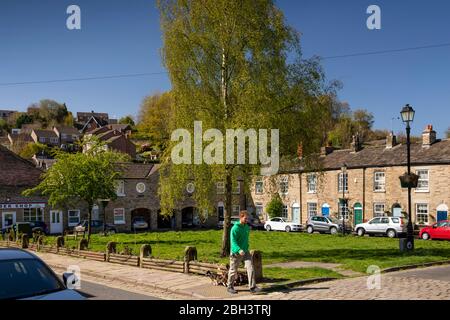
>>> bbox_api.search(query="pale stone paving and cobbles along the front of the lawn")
[36,253,450,300]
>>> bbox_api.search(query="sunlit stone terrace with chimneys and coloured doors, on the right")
[251,126,450,226]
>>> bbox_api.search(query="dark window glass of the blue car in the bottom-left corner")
[0,259,65,299]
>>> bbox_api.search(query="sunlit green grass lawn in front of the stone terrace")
[47,230,450,279]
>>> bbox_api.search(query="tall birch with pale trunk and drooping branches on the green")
[159,0,336,256]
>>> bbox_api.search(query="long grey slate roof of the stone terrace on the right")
[280,139,450,172]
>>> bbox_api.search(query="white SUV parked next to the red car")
[355,217,406,238]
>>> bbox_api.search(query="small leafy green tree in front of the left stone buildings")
[24,140,129,242]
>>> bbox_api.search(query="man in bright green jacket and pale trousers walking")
[227,210,260,294]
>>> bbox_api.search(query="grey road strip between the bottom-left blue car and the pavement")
[73,280,159,300]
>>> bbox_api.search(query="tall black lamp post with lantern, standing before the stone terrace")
[400,104,415,250]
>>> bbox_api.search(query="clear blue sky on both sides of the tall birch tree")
[0,0,450,137]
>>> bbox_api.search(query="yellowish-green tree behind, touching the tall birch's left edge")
[138,92,174,149]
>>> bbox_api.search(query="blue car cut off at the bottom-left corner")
[0,248,85,300]
